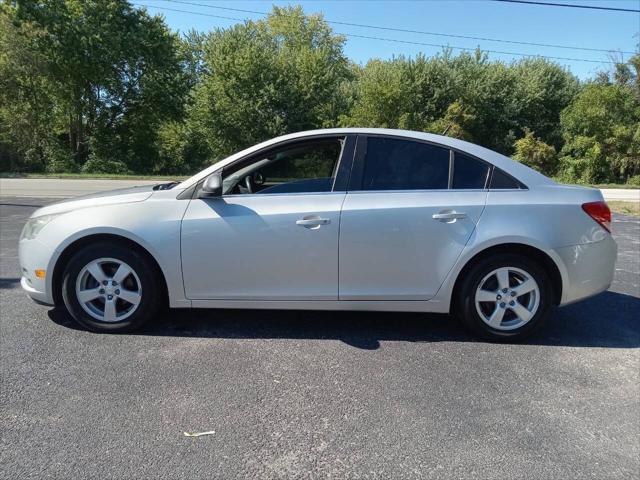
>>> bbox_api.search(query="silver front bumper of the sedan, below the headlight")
[18,239,55,305]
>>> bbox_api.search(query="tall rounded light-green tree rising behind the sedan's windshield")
[187,7,351,158]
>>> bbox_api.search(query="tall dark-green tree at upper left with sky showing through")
[7,0,186,171]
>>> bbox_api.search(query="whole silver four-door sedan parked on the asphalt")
[19,128,617,340]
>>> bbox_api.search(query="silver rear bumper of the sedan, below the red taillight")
[555,235,618,305]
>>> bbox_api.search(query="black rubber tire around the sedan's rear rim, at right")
[453,253,554,342]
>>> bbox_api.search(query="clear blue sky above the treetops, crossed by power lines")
[131,0,640,79]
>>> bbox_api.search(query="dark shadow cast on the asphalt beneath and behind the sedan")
[49,292,640,350]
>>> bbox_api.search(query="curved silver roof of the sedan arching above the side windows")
[181,128,554,188]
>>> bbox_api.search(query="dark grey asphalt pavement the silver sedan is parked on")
[0,198,640,480]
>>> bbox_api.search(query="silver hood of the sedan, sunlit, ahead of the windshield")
[31,185,156,217]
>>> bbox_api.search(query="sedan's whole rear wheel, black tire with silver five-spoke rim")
[455,254,553,341]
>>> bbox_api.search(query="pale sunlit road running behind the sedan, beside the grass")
[0,178,640,202]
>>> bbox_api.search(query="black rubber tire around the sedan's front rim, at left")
[62,242,166,333]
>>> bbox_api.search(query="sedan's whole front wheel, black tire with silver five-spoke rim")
[62,243,163,332]
